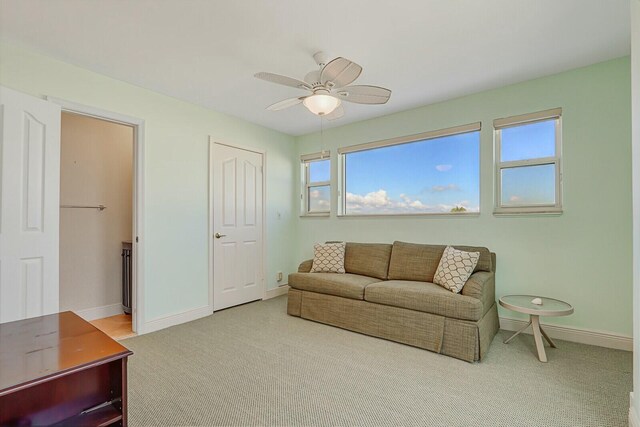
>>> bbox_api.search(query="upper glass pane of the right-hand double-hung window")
[500,119,556,162]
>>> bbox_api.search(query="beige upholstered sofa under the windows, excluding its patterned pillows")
[287,242,499,362]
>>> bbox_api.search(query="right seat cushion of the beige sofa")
[364,280,483,321]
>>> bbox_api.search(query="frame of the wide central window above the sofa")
[337,122,482,218]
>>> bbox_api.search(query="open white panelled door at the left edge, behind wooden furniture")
[0,87,60,323]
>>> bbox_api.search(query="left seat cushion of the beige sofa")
[289,273,380,299]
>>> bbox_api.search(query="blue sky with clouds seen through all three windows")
[310,120,555,214]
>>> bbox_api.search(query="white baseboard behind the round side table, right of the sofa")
[500,317,640,352]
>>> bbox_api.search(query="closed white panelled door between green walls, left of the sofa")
[210,143,263,310]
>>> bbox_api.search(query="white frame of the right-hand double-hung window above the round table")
[493,108,563,215]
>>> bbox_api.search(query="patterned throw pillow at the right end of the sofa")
[433,246,480,293]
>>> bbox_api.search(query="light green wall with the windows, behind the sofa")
[297,57,632,335]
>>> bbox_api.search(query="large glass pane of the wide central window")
[345,132,480,215]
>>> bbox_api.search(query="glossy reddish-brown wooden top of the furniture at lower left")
[0,311,133,395]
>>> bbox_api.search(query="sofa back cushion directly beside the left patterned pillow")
[344,242,392,280]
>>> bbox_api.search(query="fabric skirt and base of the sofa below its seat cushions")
[287,288,499,362]
